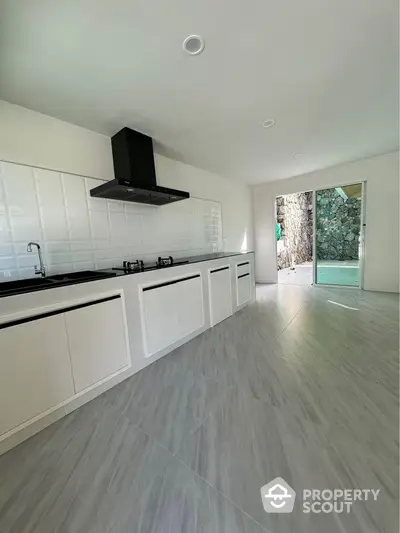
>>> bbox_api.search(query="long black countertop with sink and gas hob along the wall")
[0,251,254,298]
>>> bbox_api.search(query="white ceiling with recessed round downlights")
[0,0,399,183]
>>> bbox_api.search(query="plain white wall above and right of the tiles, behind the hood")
[0,101,253,268]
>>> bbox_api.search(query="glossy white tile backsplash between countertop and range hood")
[0,161,223,282]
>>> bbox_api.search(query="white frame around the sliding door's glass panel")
[312,181,366,290]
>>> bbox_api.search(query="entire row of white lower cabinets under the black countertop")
[0,254,255,454]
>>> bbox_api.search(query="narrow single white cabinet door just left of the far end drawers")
[208,265,232,326]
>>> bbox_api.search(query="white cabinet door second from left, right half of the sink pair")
[65,296,129,393]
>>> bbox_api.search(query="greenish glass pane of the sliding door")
[315,183,362,287]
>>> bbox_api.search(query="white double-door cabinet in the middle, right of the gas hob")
[141,274,204,357]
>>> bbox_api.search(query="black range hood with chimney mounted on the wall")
[90,128,190,205]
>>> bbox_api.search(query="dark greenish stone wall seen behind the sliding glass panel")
[316,189,361,261]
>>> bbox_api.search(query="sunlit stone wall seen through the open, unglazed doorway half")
[276,192,313,268]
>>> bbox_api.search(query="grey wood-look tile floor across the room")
[0,286,399,533]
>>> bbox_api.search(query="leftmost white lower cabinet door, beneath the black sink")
[0,314,74,434]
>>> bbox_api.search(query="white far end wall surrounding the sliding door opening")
[253,152,400,292]
